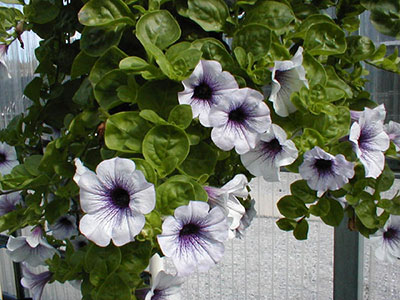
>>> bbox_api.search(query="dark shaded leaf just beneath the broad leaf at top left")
[80,24,125,57]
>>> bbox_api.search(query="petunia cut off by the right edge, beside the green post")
[370,215,400,262]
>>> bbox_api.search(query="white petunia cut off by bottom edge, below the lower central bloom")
[145,271,183,300]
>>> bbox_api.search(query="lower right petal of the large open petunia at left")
[112,210,146,247]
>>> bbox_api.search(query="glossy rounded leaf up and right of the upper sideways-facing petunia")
[304,23,347,55]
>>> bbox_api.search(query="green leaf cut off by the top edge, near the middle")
[186,0,229,31]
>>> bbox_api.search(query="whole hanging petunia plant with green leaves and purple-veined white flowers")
[0,0,400,300]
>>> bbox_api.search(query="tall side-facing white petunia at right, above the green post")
[349,106,390,178]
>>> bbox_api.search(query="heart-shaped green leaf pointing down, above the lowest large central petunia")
[143,125,189,177]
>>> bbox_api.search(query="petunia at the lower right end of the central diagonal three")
[240,124,298,181]
